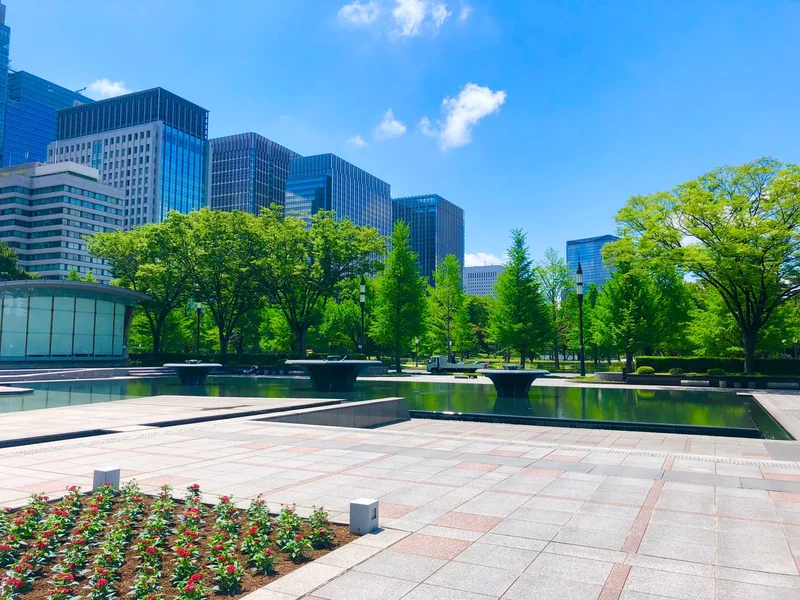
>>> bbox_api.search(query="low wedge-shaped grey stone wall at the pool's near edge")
[256,398,410,429]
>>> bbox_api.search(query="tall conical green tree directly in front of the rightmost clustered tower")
[370,221,427,373]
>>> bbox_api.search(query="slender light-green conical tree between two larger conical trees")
[428,254,475,362]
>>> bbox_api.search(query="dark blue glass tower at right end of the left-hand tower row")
[392,194,464,285]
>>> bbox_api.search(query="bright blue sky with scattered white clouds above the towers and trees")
[4,0,800,258]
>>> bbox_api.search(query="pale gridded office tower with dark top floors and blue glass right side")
[47,88,211,229]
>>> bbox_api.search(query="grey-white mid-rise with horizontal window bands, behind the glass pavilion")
[0,162,125,283]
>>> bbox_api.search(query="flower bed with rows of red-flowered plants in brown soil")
[0,483,354,600]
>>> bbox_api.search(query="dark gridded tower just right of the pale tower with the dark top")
[210,133,300,215]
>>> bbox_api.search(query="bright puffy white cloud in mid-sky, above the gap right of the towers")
[419,83,506,152]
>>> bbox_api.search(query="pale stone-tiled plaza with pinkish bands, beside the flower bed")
[0,395,800,600]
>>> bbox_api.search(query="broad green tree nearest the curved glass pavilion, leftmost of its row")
[88,223,190,355]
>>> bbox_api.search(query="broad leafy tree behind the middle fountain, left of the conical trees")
[254,207,386,357]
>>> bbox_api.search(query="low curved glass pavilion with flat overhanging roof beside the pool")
[0,280,148,364]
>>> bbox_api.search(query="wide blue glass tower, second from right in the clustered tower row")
[286,154,392,237]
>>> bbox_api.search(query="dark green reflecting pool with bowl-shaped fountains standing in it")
[0,377,791,439]
